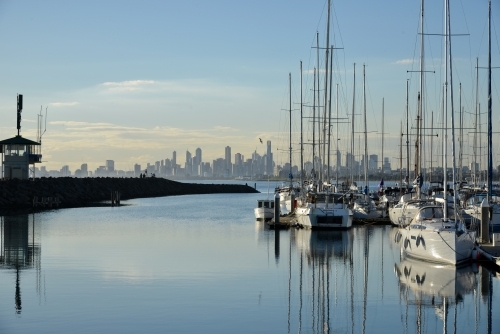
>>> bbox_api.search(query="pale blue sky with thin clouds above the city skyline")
[0,0,500,171]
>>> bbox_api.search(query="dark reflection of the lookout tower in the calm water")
[0,215,41,314]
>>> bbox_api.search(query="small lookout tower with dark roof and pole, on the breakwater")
[0,94,42,180]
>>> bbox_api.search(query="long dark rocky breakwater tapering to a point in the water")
[0,177,258,214]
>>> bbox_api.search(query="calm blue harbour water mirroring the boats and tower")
[0,181,500,333]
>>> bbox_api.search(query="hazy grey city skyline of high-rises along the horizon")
[35,141,500,181]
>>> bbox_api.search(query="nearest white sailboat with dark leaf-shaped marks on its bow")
[402,0,476,265]
